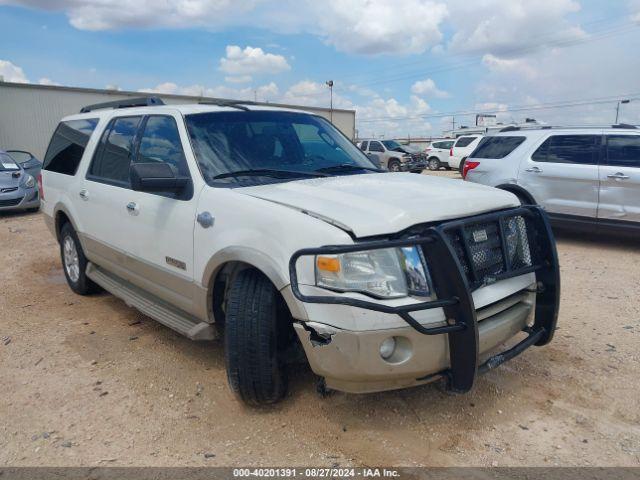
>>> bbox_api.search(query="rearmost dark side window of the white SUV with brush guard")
[42,118,98,175]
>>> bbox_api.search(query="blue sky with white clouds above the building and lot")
[0,0,640,138]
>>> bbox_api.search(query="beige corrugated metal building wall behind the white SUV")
[0,82,355,159]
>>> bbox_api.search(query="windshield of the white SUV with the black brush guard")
[186,111,376,186]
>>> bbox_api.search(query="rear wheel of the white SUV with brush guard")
[60,223,100,295]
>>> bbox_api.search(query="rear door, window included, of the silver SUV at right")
[518,134,601,218]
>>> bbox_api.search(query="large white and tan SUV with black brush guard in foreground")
[41,97,560,404]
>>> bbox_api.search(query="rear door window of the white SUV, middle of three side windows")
[87,117,142,186]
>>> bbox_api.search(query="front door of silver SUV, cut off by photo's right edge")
[598,133,640,222]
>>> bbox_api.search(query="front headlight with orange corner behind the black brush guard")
[316,247,433,298]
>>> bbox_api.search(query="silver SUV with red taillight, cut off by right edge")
[463,125,640,231]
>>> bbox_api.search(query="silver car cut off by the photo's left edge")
[0,150,40,211]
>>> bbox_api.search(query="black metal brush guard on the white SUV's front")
[289,206,560,393]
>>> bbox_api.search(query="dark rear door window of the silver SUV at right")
[531,135,600,165]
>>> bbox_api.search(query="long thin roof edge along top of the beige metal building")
[0,81,355,115]
